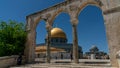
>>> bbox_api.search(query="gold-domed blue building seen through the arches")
[35,28,83,59]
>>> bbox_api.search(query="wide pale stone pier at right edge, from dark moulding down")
[104,7,120,67]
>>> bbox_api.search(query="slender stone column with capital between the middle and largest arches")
[71,18,79,63]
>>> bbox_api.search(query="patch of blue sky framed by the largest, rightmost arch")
[78,5,109,53]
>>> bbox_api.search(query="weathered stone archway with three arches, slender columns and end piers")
[25,0,120,66]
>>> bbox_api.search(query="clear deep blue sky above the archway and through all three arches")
[0,0,109,53]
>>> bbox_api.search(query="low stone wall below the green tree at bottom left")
[0,56,25,68]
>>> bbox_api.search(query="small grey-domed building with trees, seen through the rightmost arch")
[84,46,109,59]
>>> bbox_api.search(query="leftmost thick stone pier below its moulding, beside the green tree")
[25,31,36,63]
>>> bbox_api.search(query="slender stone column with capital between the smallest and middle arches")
[46,24,51,63]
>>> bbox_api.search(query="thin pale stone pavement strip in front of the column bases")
[10,63,117,68]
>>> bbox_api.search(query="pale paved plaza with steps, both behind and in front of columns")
[10,59,117,68]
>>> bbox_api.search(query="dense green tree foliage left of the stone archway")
[0,21,27,56]
